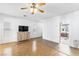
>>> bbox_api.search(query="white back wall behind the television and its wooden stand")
[1,16,41,43]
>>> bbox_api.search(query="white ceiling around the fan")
[0,3,79,21]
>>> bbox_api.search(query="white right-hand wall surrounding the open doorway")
[43,11,79,47]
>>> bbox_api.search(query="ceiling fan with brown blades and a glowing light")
[21,3,46,14]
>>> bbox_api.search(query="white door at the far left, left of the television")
[3,22,11,43]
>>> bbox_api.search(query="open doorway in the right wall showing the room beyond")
[60,23,69,45]
